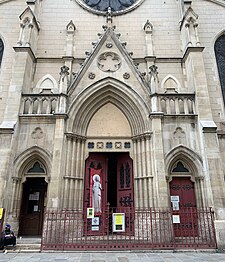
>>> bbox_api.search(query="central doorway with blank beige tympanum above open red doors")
[84,102,134,234]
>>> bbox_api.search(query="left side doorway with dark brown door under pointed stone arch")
[10,146,52,235]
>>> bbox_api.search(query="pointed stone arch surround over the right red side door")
[165,145,205,207]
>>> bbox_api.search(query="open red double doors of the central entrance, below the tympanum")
[84,152,134,234]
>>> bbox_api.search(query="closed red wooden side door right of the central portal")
[170,177,198,237]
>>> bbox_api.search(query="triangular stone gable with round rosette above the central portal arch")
[68,27,150,100]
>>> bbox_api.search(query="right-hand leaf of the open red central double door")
[117,153,134,234]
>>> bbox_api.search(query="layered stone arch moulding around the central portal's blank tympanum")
[67,78,150,136]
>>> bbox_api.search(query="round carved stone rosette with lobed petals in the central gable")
[97,52,121,72]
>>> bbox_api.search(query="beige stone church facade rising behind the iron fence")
[0,0,225,248]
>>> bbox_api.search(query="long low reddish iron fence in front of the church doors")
[41,208,216,251]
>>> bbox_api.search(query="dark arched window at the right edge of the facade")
[215,35,225,103]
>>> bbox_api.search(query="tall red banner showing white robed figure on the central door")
[90,168,102,213]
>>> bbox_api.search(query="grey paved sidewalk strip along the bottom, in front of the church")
[0,252,225,262]
